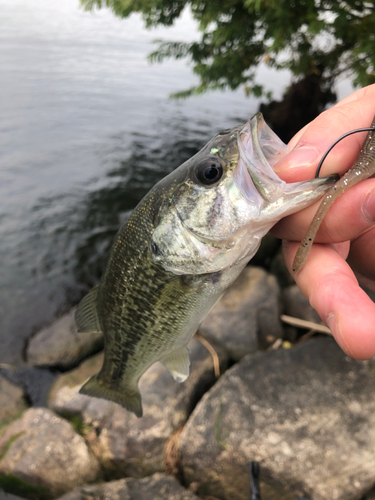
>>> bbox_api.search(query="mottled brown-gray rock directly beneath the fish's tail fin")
[49,339,227,478]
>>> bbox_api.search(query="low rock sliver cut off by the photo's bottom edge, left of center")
[58,474,207,500]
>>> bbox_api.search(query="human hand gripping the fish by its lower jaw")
[272,85,375,359]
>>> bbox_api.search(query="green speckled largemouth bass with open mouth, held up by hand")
[76,113,337,417]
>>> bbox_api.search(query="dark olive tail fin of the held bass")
[79,374,143,417]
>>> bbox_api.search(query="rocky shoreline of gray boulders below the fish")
[0,243,375,500]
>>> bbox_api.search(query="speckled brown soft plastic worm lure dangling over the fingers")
[292,117,375,275]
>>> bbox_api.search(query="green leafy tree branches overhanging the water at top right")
[81,0,375,97]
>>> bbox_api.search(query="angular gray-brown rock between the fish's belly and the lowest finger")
[199,266,283,361]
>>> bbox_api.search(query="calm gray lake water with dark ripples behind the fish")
[0,0,351,365]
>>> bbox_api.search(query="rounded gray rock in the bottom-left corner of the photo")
[0,408,100,500]
